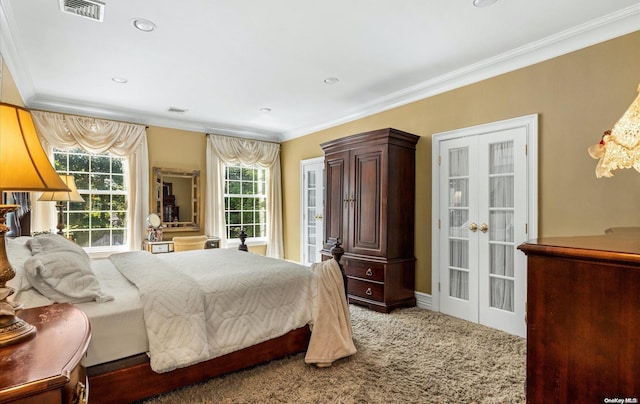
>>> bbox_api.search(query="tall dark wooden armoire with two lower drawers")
[321,128,420,313]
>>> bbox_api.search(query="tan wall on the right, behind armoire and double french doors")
[282,32,640,293]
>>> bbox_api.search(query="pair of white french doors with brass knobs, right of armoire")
[436,117,529,336]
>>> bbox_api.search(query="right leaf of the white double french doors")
[478,128,527,336]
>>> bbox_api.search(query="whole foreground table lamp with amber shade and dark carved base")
[0,103,69,347]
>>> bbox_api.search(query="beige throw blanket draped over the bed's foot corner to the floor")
[304,259,356,367]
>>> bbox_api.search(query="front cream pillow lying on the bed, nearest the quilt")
[25,250,113,303]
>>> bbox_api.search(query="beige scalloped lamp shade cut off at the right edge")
[589,84,640,178]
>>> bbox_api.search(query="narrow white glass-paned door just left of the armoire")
[300,157,324,266]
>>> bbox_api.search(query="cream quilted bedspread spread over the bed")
[111,249,316,372]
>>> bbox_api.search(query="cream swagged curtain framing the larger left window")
[31,111,149,250]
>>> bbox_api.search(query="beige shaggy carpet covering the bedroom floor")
[140,305,526,404]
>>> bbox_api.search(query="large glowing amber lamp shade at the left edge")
[0,103,69,191]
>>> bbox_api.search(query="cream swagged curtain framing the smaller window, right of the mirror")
[204,134,284,258]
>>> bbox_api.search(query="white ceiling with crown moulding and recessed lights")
[0,0,640,140]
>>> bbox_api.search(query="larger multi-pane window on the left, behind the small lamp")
[54,148,128,249]
